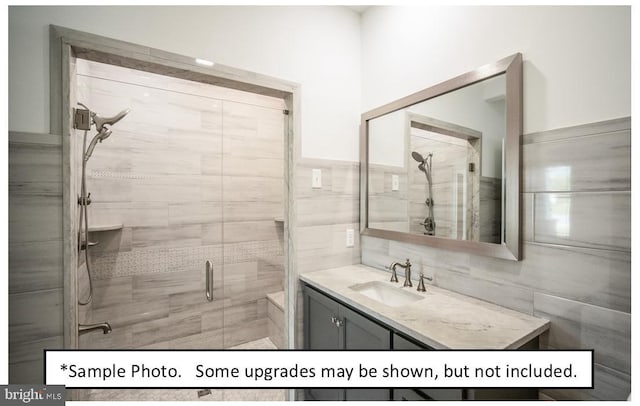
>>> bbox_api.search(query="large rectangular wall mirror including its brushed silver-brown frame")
[360,53,522,260]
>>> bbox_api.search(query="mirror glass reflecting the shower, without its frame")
[368,74,506,244]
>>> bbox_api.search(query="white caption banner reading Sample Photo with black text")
[45,350,593,388]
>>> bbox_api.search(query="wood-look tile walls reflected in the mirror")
[368,135,502,242]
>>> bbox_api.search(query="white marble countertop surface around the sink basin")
[300,265,549,349]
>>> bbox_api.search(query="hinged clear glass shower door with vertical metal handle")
[77,60,225,349]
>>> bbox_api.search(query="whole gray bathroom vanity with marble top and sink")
[300,265,549,400]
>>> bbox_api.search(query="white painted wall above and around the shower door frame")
[9,7,361,161]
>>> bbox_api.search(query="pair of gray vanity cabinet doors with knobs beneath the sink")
[304,286,391,400]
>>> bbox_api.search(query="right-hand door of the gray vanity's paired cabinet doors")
[340,306,391,401]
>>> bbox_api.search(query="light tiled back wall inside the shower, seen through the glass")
[77,60,284,348]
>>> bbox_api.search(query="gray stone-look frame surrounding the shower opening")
[49,25,301,394]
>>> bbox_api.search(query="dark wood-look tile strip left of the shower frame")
[9,132,63,384]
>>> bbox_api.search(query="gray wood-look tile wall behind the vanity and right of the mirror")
[361,118,631,400]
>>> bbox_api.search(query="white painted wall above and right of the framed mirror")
[361,6,631,133]
